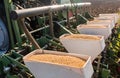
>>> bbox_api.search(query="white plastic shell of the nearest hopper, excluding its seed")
[23,50,94,78]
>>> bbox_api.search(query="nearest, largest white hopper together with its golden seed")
[23,50,93,78]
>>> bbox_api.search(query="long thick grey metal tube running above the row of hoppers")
[10,2,91,20]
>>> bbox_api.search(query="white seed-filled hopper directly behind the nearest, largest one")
[60,34,105,61]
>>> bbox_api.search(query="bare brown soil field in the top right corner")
[83,0,120,16]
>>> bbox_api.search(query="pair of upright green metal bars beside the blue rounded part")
[4,0,22,49]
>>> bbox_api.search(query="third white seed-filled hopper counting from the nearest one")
[77,24,112,39]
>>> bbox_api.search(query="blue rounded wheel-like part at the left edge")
[0,19,9,55]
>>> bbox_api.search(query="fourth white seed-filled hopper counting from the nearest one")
[87,19,115,29]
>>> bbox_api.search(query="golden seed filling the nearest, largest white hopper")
[28,54,85,68]
